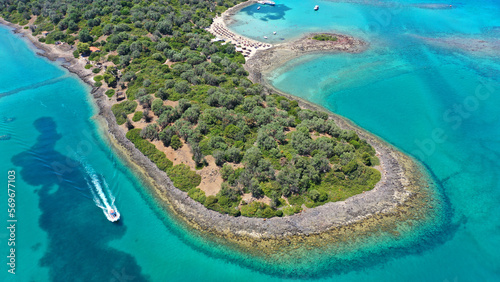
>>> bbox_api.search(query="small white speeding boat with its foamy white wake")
[82,160,120,222]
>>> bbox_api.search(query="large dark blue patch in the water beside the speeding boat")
[12,117,147,282]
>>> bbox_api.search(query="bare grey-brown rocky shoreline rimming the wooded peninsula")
[0,14,438,254]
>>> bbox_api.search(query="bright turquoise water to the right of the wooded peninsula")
[231,1,500,281]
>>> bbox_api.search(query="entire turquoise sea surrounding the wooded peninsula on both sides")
[0,0,500,281]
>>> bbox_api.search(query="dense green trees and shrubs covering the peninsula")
[0,0,380,217]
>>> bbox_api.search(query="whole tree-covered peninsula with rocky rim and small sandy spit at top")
[0,1,438,253]
